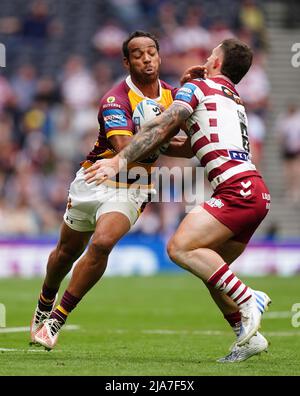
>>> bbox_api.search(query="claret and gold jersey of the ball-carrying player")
[87,76,176,188]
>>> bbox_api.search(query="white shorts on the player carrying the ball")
[64,168,153,232]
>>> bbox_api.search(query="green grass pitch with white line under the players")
[0,273,300,376]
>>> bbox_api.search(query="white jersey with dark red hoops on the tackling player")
[174,76,256,189]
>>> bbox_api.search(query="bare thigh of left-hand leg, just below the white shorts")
[57,222,93,257]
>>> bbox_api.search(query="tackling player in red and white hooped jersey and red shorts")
[86,39,271,362]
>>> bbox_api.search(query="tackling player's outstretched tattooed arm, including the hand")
[85,103,190,184]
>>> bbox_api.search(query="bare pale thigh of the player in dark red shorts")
[170,206,234,250]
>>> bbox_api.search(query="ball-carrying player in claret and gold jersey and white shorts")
[30,31,193,349]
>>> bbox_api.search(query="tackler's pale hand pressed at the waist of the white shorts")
[84,156,121,185]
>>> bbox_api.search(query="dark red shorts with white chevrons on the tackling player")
[203,174,271,243]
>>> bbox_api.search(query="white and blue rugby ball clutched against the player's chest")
[132,99,170,159]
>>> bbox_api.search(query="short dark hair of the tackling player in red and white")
[221,38,253,84]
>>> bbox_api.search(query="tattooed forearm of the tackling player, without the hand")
[119,103,191,163]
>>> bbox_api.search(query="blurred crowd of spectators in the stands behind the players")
[0,0,294,236]
